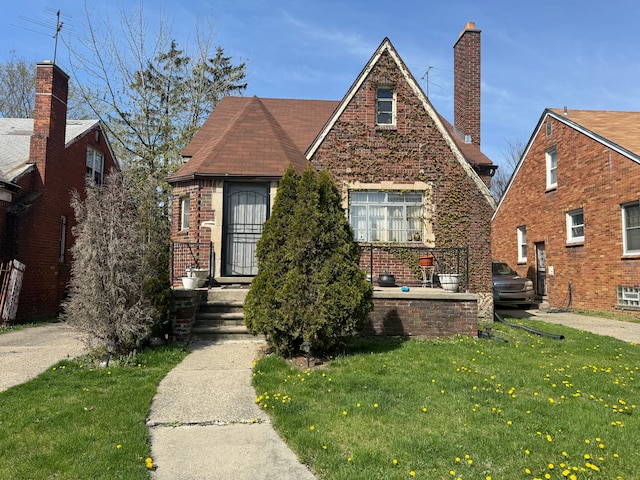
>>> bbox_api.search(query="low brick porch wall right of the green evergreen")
[362,294,478,338]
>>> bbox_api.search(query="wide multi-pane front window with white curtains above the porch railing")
[349,190,425,243]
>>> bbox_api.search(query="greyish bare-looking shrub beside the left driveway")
[63,172,159,352]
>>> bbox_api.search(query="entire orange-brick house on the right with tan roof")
[492,108,640,311]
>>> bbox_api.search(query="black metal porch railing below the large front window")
[359,243,469,291]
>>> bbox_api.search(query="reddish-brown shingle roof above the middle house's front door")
[170,97,337,182]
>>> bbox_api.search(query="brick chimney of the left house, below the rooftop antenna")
[30,61,69,184]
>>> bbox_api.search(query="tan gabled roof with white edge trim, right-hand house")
[493,108,640,218]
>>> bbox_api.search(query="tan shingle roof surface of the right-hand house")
[549,108,640,155]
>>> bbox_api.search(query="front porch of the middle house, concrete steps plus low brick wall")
[171,277,478,343]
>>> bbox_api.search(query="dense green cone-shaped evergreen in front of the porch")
[245,167,373,356]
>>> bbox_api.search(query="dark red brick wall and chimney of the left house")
[0,63,116,320]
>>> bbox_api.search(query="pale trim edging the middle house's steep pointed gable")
[307,38,496,208]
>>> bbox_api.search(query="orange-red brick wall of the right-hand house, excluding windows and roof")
[492,111,640,311]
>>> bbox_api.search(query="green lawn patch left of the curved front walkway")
[0,346,187,480]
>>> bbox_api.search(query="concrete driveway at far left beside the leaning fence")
[0,322,86,392]
